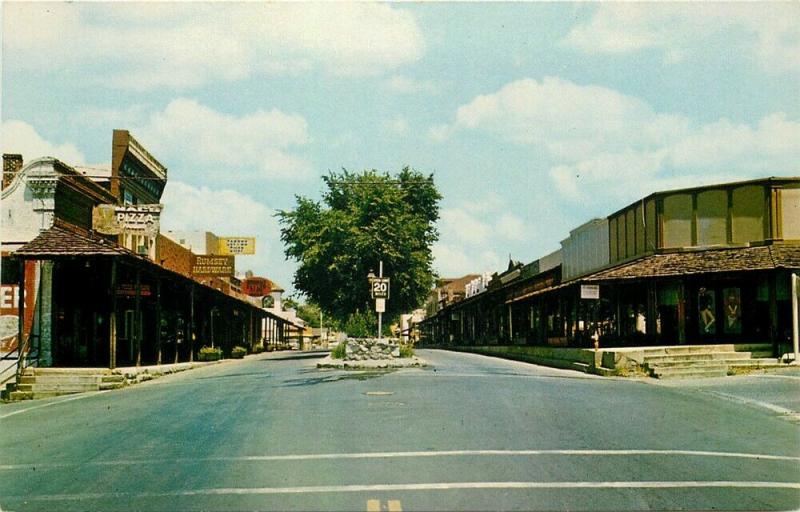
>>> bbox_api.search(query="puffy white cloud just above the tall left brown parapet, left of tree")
[135,98,312,181]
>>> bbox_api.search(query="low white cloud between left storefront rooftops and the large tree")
[161,180,292,286]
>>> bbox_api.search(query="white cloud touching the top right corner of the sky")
[564,2,800,72]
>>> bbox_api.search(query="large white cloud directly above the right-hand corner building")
[435,78,800,205]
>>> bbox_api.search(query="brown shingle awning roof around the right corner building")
[580,244,800,282]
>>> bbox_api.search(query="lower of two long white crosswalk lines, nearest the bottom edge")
[6,480,800,501]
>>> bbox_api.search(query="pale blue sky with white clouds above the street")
[0,1,800,291]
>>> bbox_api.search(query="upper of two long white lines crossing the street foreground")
[0,450,800,470]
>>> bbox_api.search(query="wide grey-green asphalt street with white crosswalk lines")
[0,351,800,511]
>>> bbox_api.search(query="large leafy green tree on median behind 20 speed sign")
[277,167,442,322]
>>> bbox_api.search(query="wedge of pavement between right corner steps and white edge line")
[647,368,800,423]
